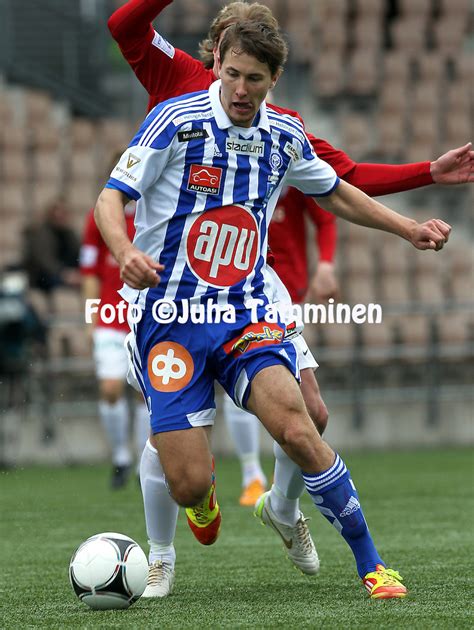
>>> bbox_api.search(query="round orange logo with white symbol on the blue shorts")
[148,341,194,392]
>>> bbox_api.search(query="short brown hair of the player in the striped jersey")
[219,20,288,76]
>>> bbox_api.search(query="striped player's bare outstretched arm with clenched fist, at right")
[318,181,451,251]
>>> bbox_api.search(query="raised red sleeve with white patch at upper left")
[108,0,215,109]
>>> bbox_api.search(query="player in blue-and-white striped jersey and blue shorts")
[95,22,451,598]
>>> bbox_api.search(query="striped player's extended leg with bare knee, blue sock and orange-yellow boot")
[247,365,406,598]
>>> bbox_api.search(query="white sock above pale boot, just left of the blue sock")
[270,442,305,525]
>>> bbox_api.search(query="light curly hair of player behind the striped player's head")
[199,2,279,69]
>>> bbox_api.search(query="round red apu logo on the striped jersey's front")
[186,206,259,288]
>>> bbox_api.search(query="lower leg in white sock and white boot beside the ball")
[140,441,179,598]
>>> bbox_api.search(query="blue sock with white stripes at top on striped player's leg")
[303,453,384,578]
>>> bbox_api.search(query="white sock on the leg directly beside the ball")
[140,441,179,566]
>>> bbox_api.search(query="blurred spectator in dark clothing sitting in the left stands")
[23,197,80,293]
